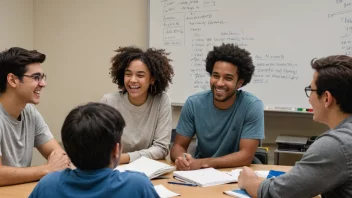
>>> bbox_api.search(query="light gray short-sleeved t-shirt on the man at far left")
[0,103,53,167]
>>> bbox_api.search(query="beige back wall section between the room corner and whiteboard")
[33,0,148,164]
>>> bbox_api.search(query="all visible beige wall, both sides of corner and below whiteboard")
[0,0,326,165]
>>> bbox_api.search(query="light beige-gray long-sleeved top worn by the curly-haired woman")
[100,92,172,162]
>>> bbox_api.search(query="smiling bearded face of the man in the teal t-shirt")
[210,61,243,109]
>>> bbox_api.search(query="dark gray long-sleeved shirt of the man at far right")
[258,116,352,198]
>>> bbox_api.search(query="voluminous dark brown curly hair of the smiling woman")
[110,46,174,95]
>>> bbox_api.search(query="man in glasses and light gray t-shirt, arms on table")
[0,47,70,186]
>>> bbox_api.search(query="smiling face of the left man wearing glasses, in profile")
[16,63,46,104]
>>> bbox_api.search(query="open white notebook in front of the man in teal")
[174,168,237,187]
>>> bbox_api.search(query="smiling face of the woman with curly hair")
[124,60,154,106]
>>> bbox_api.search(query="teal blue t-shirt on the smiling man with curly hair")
[176,90,264,158]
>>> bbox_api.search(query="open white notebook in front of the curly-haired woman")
[115,156,175,179]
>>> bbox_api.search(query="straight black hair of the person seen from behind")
[61,103,125,170]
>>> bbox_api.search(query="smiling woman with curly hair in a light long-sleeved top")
[101,47,174,163]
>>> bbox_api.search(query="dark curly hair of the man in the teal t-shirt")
[205,43,254,87]
